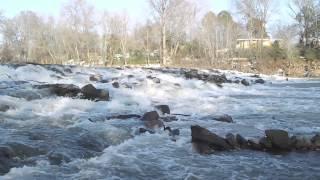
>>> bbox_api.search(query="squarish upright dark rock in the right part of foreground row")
[265,129,290,150]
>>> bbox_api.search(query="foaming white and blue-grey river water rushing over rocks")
[0,65,320,180]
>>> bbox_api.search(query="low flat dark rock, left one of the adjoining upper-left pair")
[35,84,81,97]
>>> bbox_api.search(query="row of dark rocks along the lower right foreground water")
[191,126,320,154]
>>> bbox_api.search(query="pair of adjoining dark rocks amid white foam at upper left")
[34,84,110,101]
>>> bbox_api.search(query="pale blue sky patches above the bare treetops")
[0,0,292,29]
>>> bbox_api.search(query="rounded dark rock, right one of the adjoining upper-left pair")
[81,84,109,101]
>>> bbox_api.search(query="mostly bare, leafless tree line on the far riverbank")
[0,0,320,66]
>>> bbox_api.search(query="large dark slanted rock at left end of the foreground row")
[191,126,232,151]
